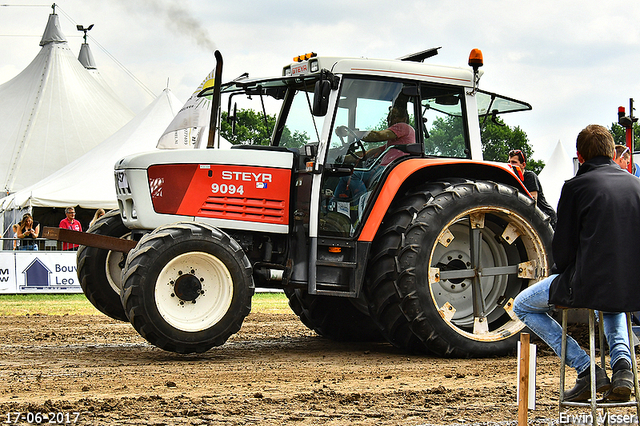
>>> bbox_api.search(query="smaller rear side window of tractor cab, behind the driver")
[420,84,471,158]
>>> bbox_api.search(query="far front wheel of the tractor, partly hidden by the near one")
[76,210,131,321]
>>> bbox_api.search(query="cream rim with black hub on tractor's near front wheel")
[155,252,233,332]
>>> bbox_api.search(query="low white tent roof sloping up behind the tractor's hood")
[5,89,181,209]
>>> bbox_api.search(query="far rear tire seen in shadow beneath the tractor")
[284,289,384,342]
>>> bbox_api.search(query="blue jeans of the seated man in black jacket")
[513,274,631,374]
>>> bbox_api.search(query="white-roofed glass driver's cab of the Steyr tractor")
[208,53,531,297]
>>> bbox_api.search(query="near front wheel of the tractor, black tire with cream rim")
[122,222,255,353]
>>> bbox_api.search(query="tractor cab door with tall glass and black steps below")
[309,78,421,297]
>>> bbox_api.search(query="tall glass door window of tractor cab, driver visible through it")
[320,78,418,237]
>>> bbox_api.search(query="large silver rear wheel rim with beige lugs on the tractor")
[429,207,548,342]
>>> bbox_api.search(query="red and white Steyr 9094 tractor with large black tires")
[71,49,553,357]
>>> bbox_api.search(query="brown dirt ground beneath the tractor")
[0,313,629,426]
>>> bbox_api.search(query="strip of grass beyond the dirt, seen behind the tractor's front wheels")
[0,293,291,316]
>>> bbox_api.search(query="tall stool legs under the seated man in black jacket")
[559,308,640,426]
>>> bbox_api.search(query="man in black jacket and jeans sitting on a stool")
[514,125,640,401]
